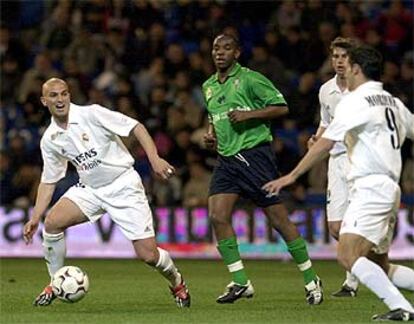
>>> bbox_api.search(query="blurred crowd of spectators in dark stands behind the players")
[0,0,414,207]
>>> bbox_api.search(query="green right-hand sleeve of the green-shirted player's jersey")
[249,71,287,108]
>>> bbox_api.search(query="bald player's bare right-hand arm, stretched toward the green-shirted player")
[133,122,175,179]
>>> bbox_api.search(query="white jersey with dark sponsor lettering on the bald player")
[40,103,138,188]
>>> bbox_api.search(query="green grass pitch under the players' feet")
[0,259,414,324]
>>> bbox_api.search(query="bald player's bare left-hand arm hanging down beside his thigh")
[23,183,56,244]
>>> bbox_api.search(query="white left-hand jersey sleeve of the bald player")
[40,141,68,183]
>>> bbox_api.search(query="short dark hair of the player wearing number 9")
[348,45,382,80]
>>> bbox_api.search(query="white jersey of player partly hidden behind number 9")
[319,75,349,155]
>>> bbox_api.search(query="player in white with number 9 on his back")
[263,45,414,321]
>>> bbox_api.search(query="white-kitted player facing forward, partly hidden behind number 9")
[308,37,414,297]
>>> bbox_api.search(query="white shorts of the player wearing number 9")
[340,175,401,254]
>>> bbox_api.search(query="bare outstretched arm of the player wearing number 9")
[263,138,335,194]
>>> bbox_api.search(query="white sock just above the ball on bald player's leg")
[42,230,66,278]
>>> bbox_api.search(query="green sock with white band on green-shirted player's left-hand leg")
[217,236,248,285]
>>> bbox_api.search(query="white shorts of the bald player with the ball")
[62,169,155,241]
